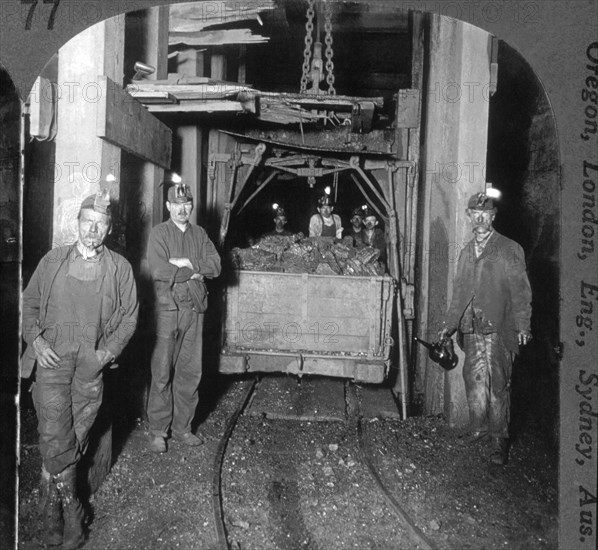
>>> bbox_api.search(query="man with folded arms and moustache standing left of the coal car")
[147,181,220,453]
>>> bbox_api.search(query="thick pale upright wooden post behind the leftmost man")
[50,15,124,246]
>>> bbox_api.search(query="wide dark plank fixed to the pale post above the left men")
[96,76,172,170]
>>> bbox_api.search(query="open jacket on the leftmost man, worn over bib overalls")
[21,244,139,378]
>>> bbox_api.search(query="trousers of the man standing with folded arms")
[147,308,204,437]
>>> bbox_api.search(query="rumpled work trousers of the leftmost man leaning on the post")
[33,342,103,475]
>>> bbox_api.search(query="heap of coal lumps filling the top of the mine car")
[230,233,385,276]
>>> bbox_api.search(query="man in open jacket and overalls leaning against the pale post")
[21,192,138,549]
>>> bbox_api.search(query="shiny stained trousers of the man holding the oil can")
[463,333,513,438]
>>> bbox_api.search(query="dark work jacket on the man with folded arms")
[147,220,220,313]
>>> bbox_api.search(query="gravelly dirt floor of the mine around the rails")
[19,380,557,550]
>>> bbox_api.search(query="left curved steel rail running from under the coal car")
[212,378,258,550]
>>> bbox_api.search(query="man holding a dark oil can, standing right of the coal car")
[439,193,532,465]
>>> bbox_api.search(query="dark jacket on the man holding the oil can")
[446,230,532,353]
